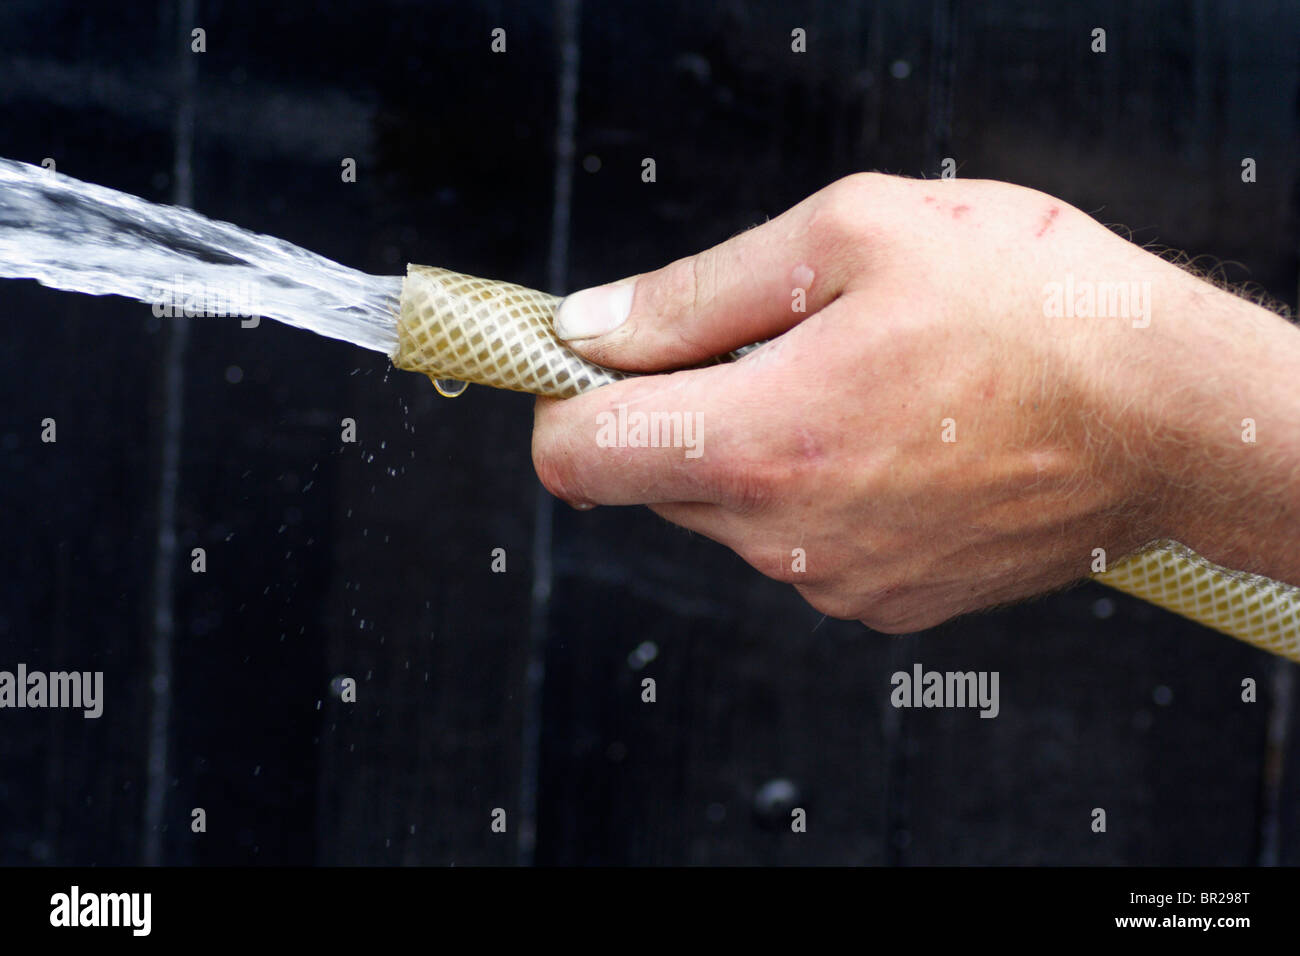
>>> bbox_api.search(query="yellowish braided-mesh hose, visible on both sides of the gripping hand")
[393,265,1300,661]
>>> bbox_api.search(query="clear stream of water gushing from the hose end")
[0,159,402,355]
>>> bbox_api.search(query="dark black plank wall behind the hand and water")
[0,0,1300,865]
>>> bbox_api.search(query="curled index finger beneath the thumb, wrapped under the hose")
[533,365,745,505]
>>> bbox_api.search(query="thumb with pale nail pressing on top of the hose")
[555,183,861,372]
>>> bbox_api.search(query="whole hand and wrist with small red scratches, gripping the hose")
[533,174,1300,633]
